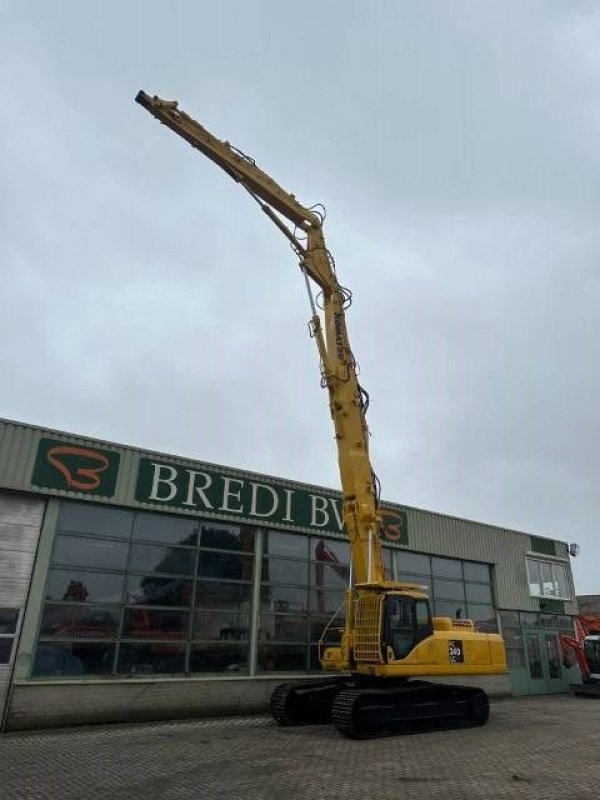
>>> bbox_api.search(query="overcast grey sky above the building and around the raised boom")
[0,0,600,593]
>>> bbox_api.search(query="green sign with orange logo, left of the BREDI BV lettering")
[31,439,121,497]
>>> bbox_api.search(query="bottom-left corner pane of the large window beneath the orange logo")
[32,642,116,678]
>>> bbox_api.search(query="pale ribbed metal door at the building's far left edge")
[0,492,45,722]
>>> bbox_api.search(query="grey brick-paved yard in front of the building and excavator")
[0,696,600,800]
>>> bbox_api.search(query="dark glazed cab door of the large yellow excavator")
[384,594,433,660]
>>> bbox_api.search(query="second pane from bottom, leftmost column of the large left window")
[40,603,119,639]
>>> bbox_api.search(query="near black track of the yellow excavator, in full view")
[331,681,490,739]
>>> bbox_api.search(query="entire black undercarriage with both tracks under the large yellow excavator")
[271,677,489,739]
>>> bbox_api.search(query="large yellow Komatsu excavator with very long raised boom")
[136,91,506,738]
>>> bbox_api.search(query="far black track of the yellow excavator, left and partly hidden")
[270,678,340,725]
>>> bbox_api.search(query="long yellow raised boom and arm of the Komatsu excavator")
[136,91,385,583]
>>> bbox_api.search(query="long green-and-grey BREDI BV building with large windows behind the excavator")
[0,420,577,730]
